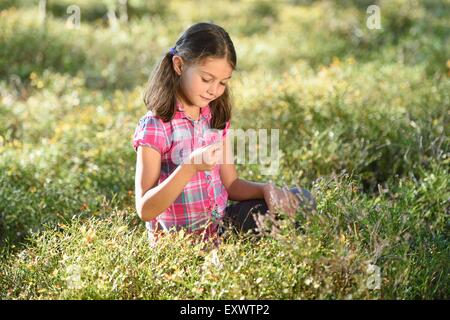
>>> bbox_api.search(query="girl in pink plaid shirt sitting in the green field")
[133,23,314,242]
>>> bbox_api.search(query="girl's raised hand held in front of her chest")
[185,142,223,172]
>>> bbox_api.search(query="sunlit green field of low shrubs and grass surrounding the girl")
[0,0,450,299]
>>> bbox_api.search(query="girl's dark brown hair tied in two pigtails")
[144,22,236,129]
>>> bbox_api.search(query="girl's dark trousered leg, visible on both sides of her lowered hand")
[219,187,316,234]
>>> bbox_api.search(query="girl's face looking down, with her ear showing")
[173,56,233,108]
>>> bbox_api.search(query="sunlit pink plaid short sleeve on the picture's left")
[133,115,168,155]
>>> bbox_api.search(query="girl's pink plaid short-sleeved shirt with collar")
[133,101,230,237]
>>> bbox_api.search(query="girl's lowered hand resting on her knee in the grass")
[263,183,300,217]
